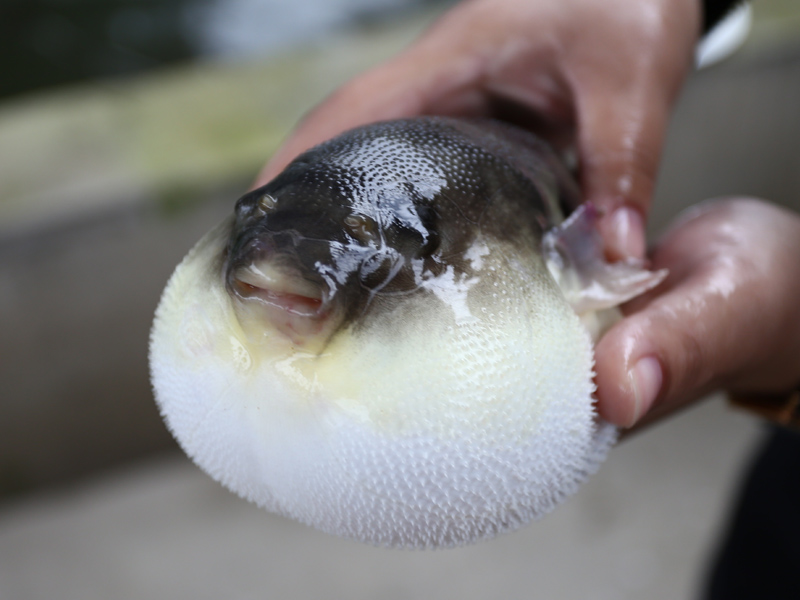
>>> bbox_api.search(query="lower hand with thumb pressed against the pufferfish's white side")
[595,199,800,427]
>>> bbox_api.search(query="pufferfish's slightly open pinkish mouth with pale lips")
[228,260,337,349]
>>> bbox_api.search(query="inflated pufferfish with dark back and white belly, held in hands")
[150,117,664,548]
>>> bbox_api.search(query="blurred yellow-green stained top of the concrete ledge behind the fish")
[0,11,436,239]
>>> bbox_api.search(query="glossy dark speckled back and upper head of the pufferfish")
[226,117,577,330]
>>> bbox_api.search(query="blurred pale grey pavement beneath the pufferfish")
[0,399,760,600]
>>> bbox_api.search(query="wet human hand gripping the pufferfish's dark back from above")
[256,0,701,259]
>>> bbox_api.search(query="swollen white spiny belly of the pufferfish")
[151,221,615,547]
